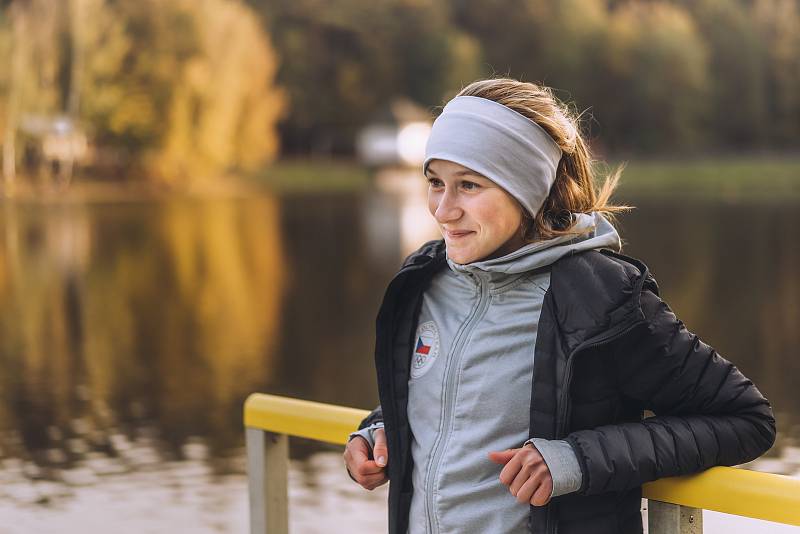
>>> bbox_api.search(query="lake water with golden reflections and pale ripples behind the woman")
[0,178,800,534]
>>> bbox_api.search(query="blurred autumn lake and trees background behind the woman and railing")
[0,0,800,534]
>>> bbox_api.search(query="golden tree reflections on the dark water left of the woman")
[0,197,285,478]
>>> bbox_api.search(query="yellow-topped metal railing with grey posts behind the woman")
[244,393,800,534]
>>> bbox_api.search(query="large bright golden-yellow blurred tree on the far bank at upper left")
[81,0,283,182]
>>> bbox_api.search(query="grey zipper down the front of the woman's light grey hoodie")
[425,276,489,534]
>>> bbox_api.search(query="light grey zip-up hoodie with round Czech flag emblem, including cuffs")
[354,213,620,534]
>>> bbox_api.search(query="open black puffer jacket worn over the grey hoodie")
[361,241,775,534]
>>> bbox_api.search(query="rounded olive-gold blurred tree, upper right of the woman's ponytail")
[595,1,710,152]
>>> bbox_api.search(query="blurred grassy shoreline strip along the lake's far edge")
[0,154,800,203]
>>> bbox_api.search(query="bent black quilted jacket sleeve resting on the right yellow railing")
[566,289,775,495]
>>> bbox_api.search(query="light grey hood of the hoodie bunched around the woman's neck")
[447,212,622,281]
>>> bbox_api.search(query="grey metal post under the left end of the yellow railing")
[246,427,289,534]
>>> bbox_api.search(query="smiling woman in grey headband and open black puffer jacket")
[344,79,775,534]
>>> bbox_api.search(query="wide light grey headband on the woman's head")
[422,96,561,216]
